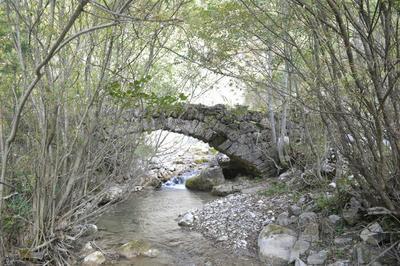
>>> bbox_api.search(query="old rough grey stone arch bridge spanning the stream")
[132,104,286,176]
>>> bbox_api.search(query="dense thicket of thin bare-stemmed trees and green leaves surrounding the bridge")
[0,0,400,264]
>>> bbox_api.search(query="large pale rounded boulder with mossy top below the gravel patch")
[258,224,297,266]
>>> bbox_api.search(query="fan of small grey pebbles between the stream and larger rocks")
[181,194,287,256]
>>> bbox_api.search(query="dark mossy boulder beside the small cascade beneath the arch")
[185,166,224,191]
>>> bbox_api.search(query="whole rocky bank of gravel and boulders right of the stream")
[178,170,400,266]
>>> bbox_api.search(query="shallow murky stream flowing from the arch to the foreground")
[97,169,259,266]
